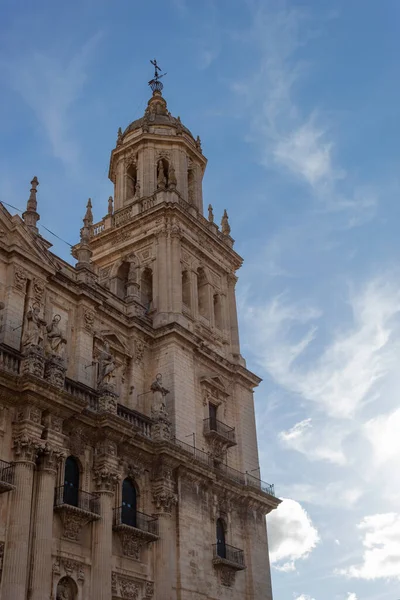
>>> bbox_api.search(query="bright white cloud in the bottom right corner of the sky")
[337,513,400,580]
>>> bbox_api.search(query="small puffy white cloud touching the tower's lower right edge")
[267,499,319,572]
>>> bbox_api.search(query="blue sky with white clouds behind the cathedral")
[0,0,400,600]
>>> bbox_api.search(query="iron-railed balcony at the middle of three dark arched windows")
[113,506,159,560]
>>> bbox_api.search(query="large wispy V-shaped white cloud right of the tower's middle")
[245,275,400,420]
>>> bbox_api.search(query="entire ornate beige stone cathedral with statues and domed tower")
[0,63,280,600]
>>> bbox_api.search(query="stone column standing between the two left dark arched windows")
[90,452,119,600]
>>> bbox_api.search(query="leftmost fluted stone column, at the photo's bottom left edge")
[1,434,39,600]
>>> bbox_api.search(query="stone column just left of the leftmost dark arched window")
[30,443,62,600]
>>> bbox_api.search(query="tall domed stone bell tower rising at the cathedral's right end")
[69,65,279,600]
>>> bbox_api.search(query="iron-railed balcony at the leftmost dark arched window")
[54,485,100,542]
